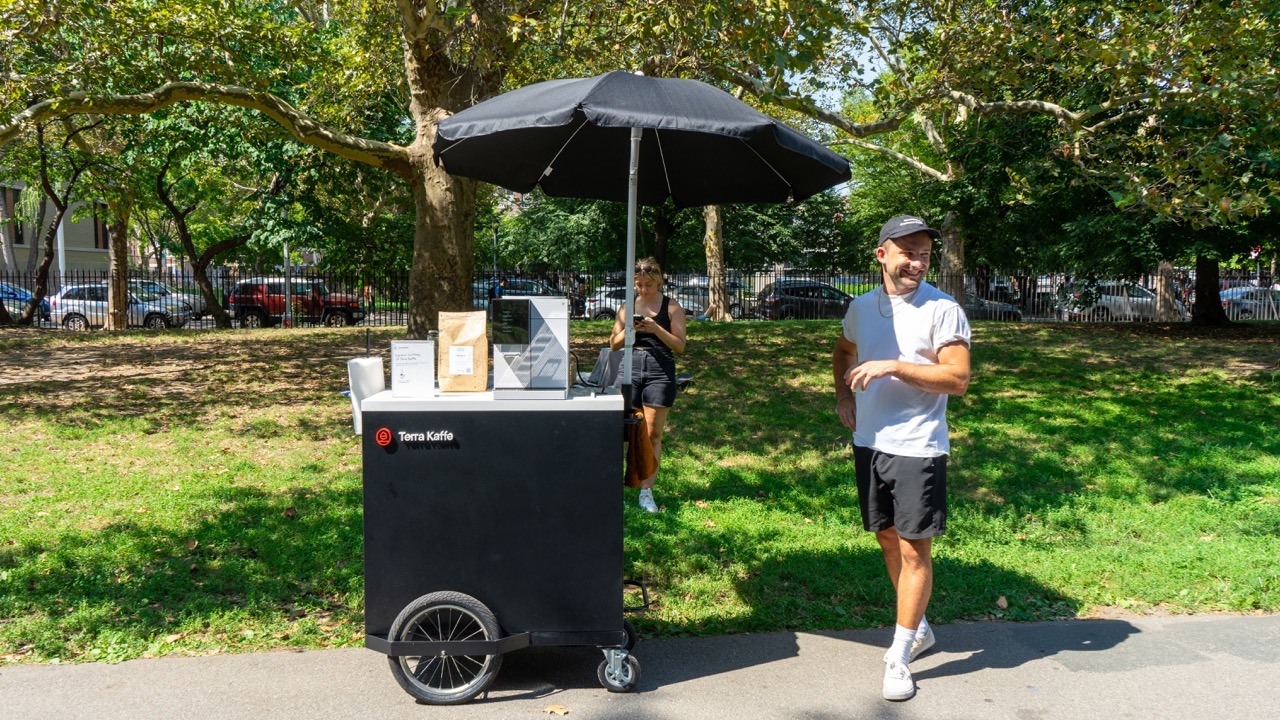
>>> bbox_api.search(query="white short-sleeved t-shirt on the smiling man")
[844,282,970,457]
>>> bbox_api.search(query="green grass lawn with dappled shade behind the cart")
[0,322,1280,662]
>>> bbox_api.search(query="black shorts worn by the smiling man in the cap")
[854,445,947,539]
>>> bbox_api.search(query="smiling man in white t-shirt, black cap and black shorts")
[832,215,970,700]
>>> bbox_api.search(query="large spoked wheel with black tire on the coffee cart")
[388,592,502,705]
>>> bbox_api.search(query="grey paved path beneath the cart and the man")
[0,615,1280,720]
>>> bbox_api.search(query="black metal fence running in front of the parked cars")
[0,268,1280,329]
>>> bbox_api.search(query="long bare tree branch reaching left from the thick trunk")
[0,82,412,178]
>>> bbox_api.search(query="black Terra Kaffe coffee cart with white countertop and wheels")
[362,391,640,705]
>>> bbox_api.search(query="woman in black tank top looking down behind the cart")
[609,258,685,512]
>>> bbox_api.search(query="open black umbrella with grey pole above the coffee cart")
[433,72,850,406]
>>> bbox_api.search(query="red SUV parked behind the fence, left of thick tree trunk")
[227,278,365,328]
